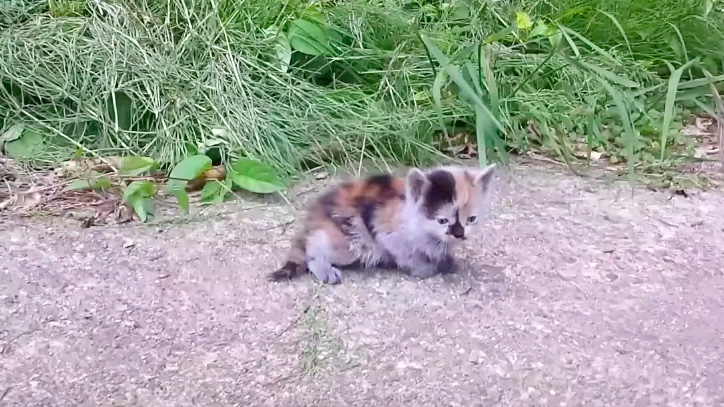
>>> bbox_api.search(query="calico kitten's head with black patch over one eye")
[405,164,495,241]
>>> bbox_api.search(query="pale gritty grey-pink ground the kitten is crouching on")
[0,169,724,407]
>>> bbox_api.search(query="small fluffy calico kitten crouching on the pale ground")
[268,165,495,284]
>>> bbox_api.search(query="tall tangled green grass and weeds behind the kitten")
[0,0,724,183]
